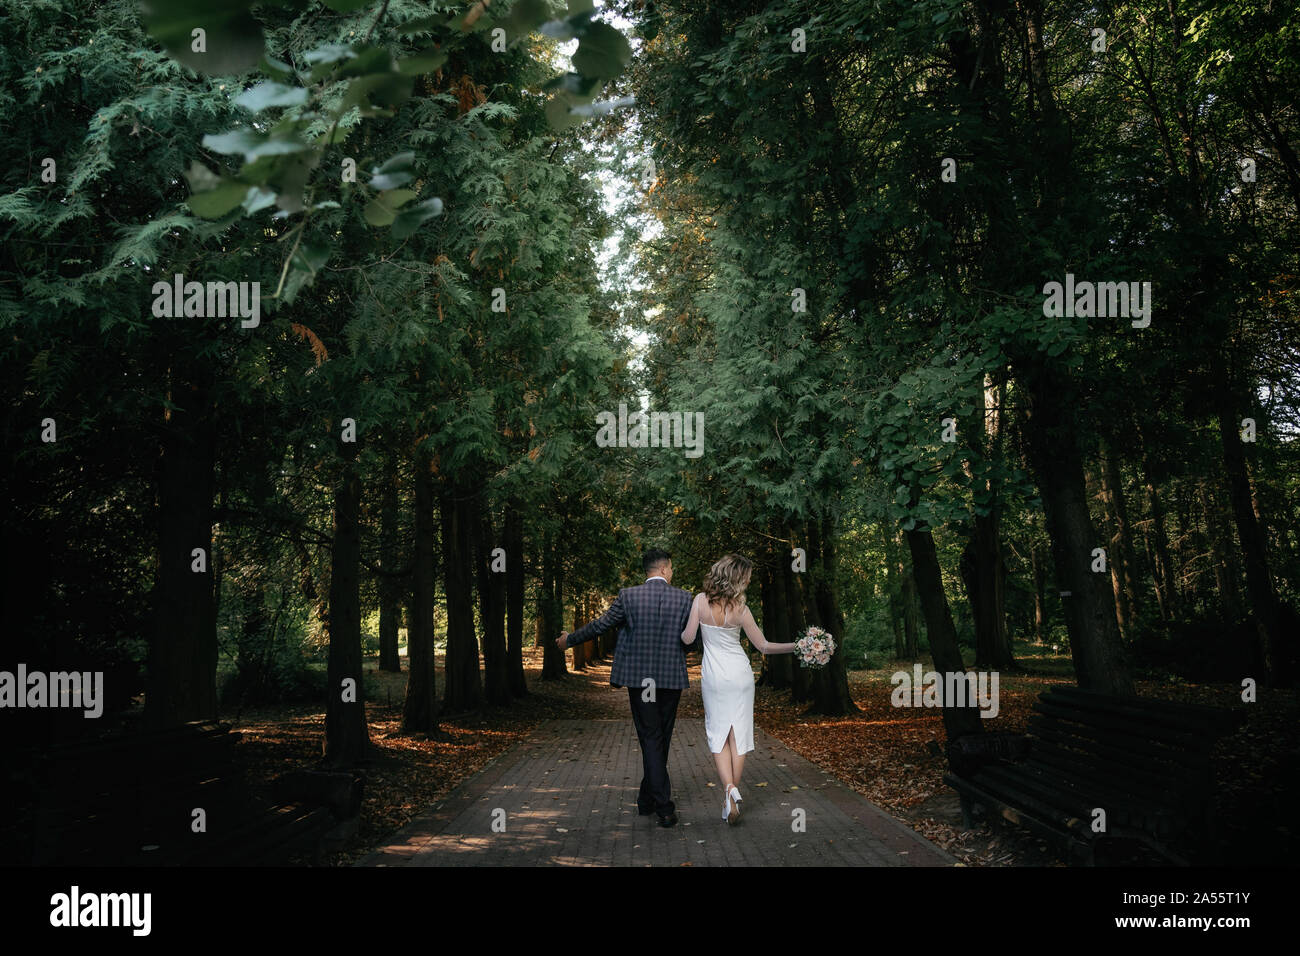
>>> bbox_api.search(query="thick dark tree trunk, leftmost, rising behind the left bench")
[144,369,217,728]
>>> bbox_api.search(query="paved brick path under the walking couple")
[358,718,956,866]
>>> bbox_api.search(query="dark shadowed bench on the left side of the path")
[4,722,361,866]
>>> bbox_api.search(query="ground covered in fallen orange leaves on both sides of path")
[226,648,1300,865]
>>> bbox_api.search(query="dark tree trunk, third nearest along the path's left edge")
[442,488,482,714]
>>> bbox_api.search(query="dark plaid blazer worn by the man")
[567,578,692,691]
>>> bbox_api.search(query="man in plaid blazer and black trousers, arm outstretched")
[555,548,692,826]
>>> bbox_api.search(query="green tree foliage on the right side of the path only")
[628,0,1300,671]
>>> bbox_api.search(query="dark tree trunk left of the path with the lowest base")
[325,441,371,769]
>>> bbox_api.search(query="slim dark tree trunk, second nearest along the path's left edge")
[402,450,438,734]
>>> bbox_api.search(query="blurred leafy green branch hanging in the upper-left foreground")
[143,0,632,298]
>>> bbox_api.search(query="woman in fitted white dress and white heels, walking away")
[681,554,794,823]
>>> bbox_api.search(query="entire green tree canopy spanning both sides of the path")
[0,0,1300,733]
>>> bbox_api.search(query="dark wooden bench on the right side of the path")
[944,687,1244,865]
